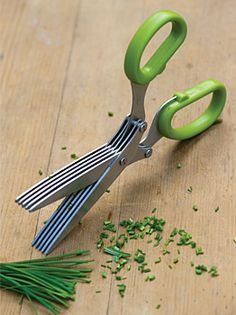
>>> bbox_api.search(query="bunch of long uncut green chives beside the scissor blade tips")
[0,250,93,314]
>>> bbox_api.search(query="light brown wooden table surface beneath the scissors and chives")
[0,0,236,315]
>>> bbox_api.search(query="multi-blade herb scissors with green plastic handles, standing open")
[16,11,226,254]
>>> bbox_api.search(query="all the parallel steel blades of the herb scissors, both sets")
[16,117,151,254]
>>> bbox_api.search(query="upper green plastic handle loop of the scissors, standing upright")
[124,11,187,85]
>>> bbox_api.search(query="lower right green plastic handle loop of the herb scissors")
[157,79,226,140]
